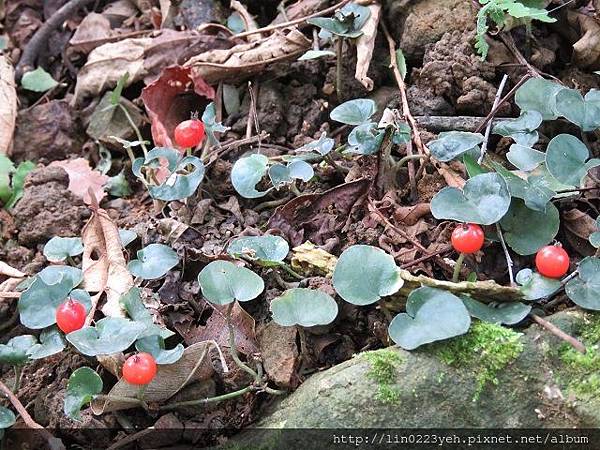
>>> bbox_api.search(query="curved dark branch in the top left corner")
[15,0,95,81]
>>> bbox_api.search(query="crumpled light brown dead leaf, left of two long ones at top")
[73,30,229,104]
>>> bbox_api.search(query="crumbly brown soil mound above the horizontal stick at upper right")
[407,31,510,115]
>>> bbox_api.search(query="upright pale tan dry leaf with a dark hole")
[81,203,133,316]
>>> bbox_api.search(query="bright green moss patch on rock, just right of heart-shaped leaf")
[434,322,523,401]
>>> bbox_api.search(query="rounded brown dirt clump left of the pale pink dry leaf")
[13,167,90,247]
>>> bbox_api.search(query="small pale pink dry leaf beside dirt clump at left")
[50,158,108,205]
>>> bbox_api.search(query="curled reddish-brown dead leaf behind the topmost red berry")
[142,66,215,147]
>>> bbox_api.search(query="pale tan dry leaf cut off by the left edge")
[0,55,17,155]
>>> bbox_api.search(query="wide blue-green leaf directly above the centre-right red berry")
[431,173,510,225]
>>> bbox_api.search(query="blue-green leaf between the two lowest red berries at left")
[67,317,146,356]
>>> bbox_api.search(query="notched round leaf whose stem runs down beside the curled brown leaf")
[198,261,265,305]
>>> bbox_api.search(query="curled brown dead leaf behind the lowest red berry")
[92,341,218,414]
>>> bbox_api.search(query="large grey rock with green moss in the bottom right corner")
[243,311,600,434]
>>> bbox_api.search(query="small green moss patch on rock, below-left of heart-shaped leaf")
[361,349,404,405]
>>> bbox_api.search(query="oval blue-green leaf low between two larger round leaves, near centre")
[271,288,338,327]
